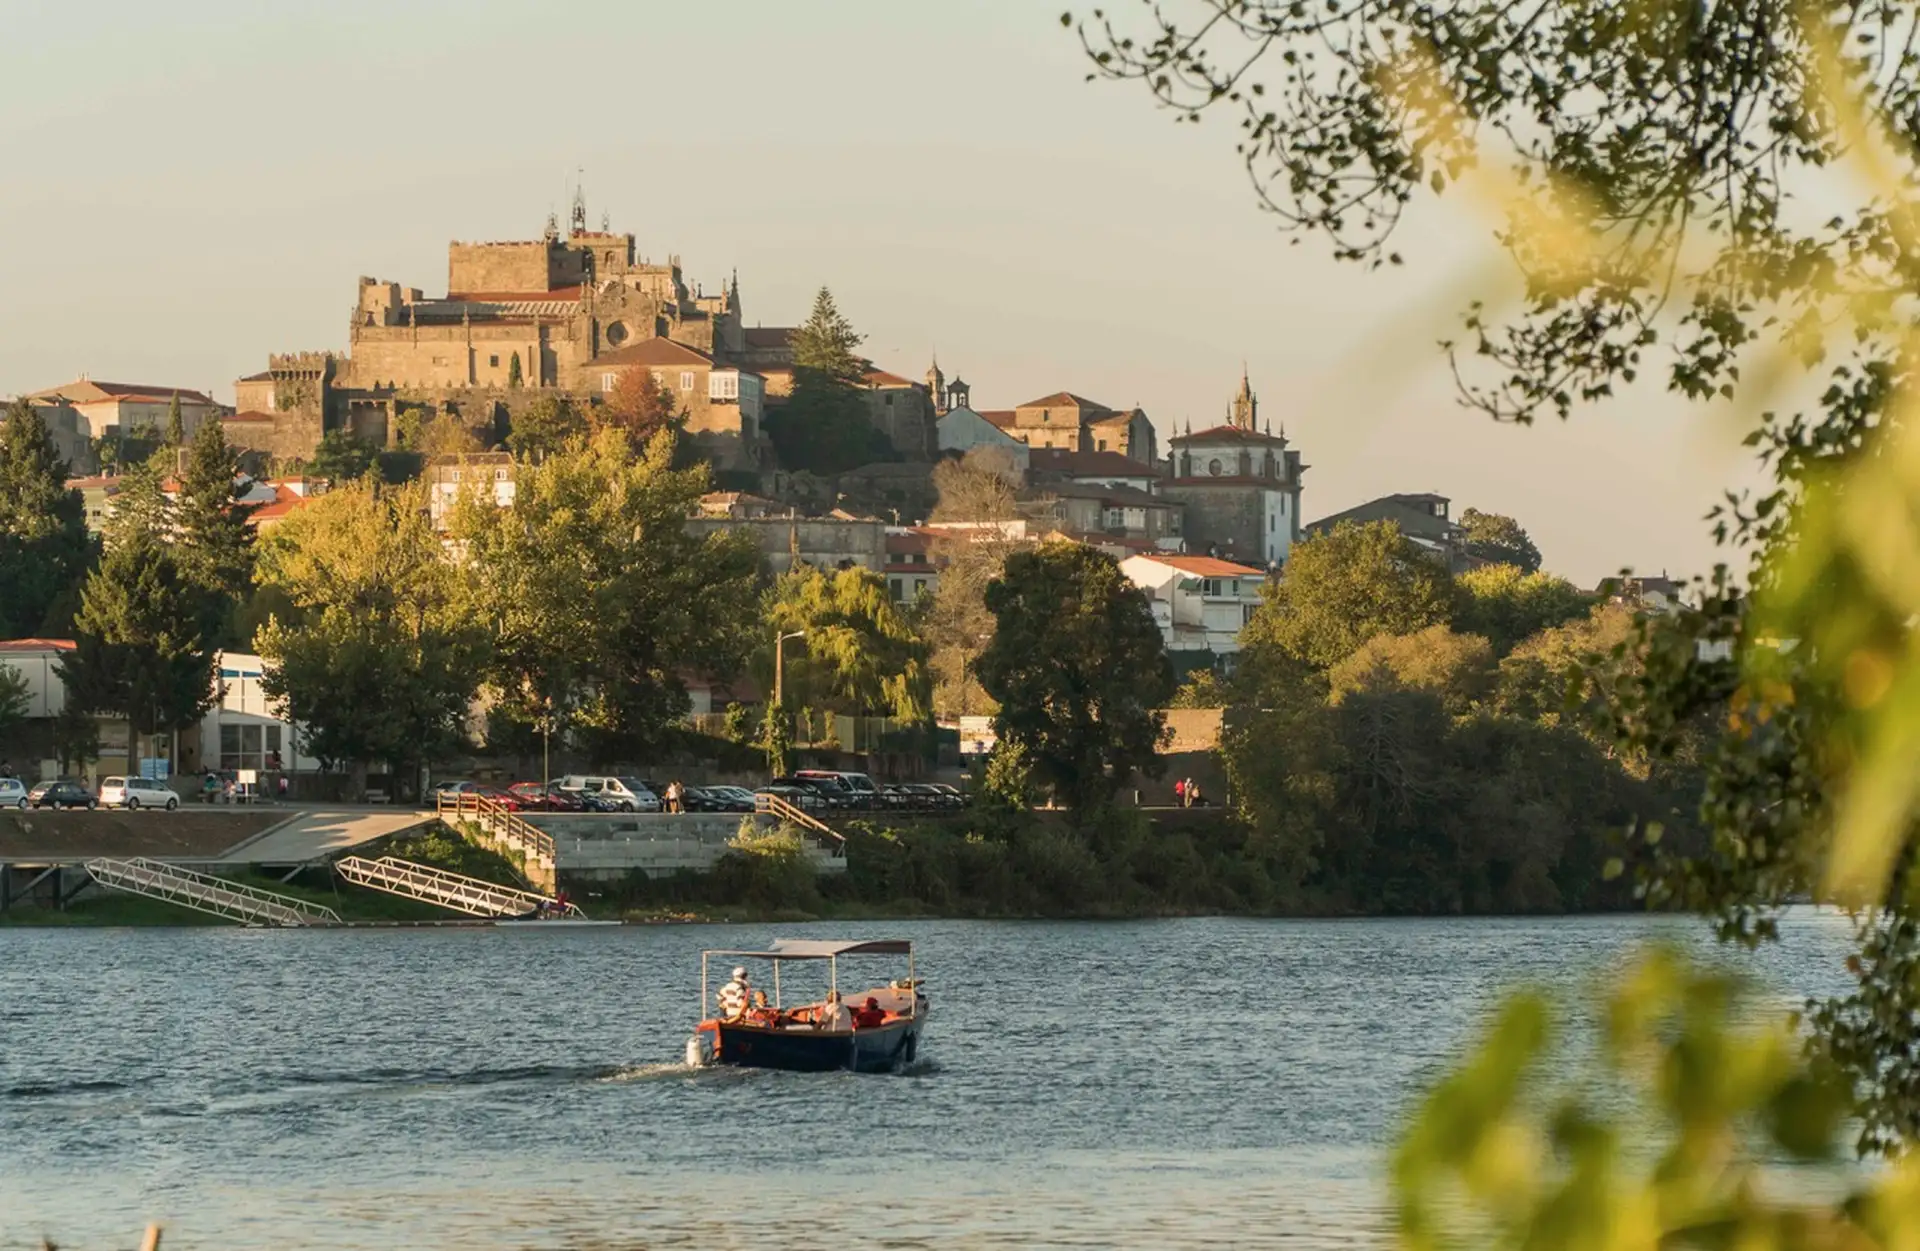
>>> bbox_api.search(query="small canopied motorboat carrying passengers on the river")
[687,938,927,1073]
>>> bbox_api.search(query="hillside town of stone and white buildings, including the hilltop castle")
[0,198,1676,796]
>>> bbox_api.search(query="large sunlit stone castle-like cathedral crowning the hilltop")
[228,196,933,470]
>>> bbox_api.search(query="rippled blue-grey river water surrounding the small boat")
[0,911,1845,1251]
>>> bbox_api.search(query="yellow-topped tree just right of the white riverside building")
[255,480,484,789]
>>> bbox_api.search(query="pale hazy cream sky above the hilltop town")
[0,0,1751,585]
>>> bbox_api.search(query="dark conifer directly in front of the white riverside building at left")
[60,533,215,756]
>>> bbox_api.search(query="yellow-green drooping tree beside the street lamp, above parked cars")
[755,566,933,721]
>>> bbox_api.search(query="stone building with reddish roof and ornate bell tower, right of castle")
[1162,374,1308,568]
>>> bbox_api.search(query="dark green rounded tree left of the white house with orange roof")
[979,543,1173,810]
